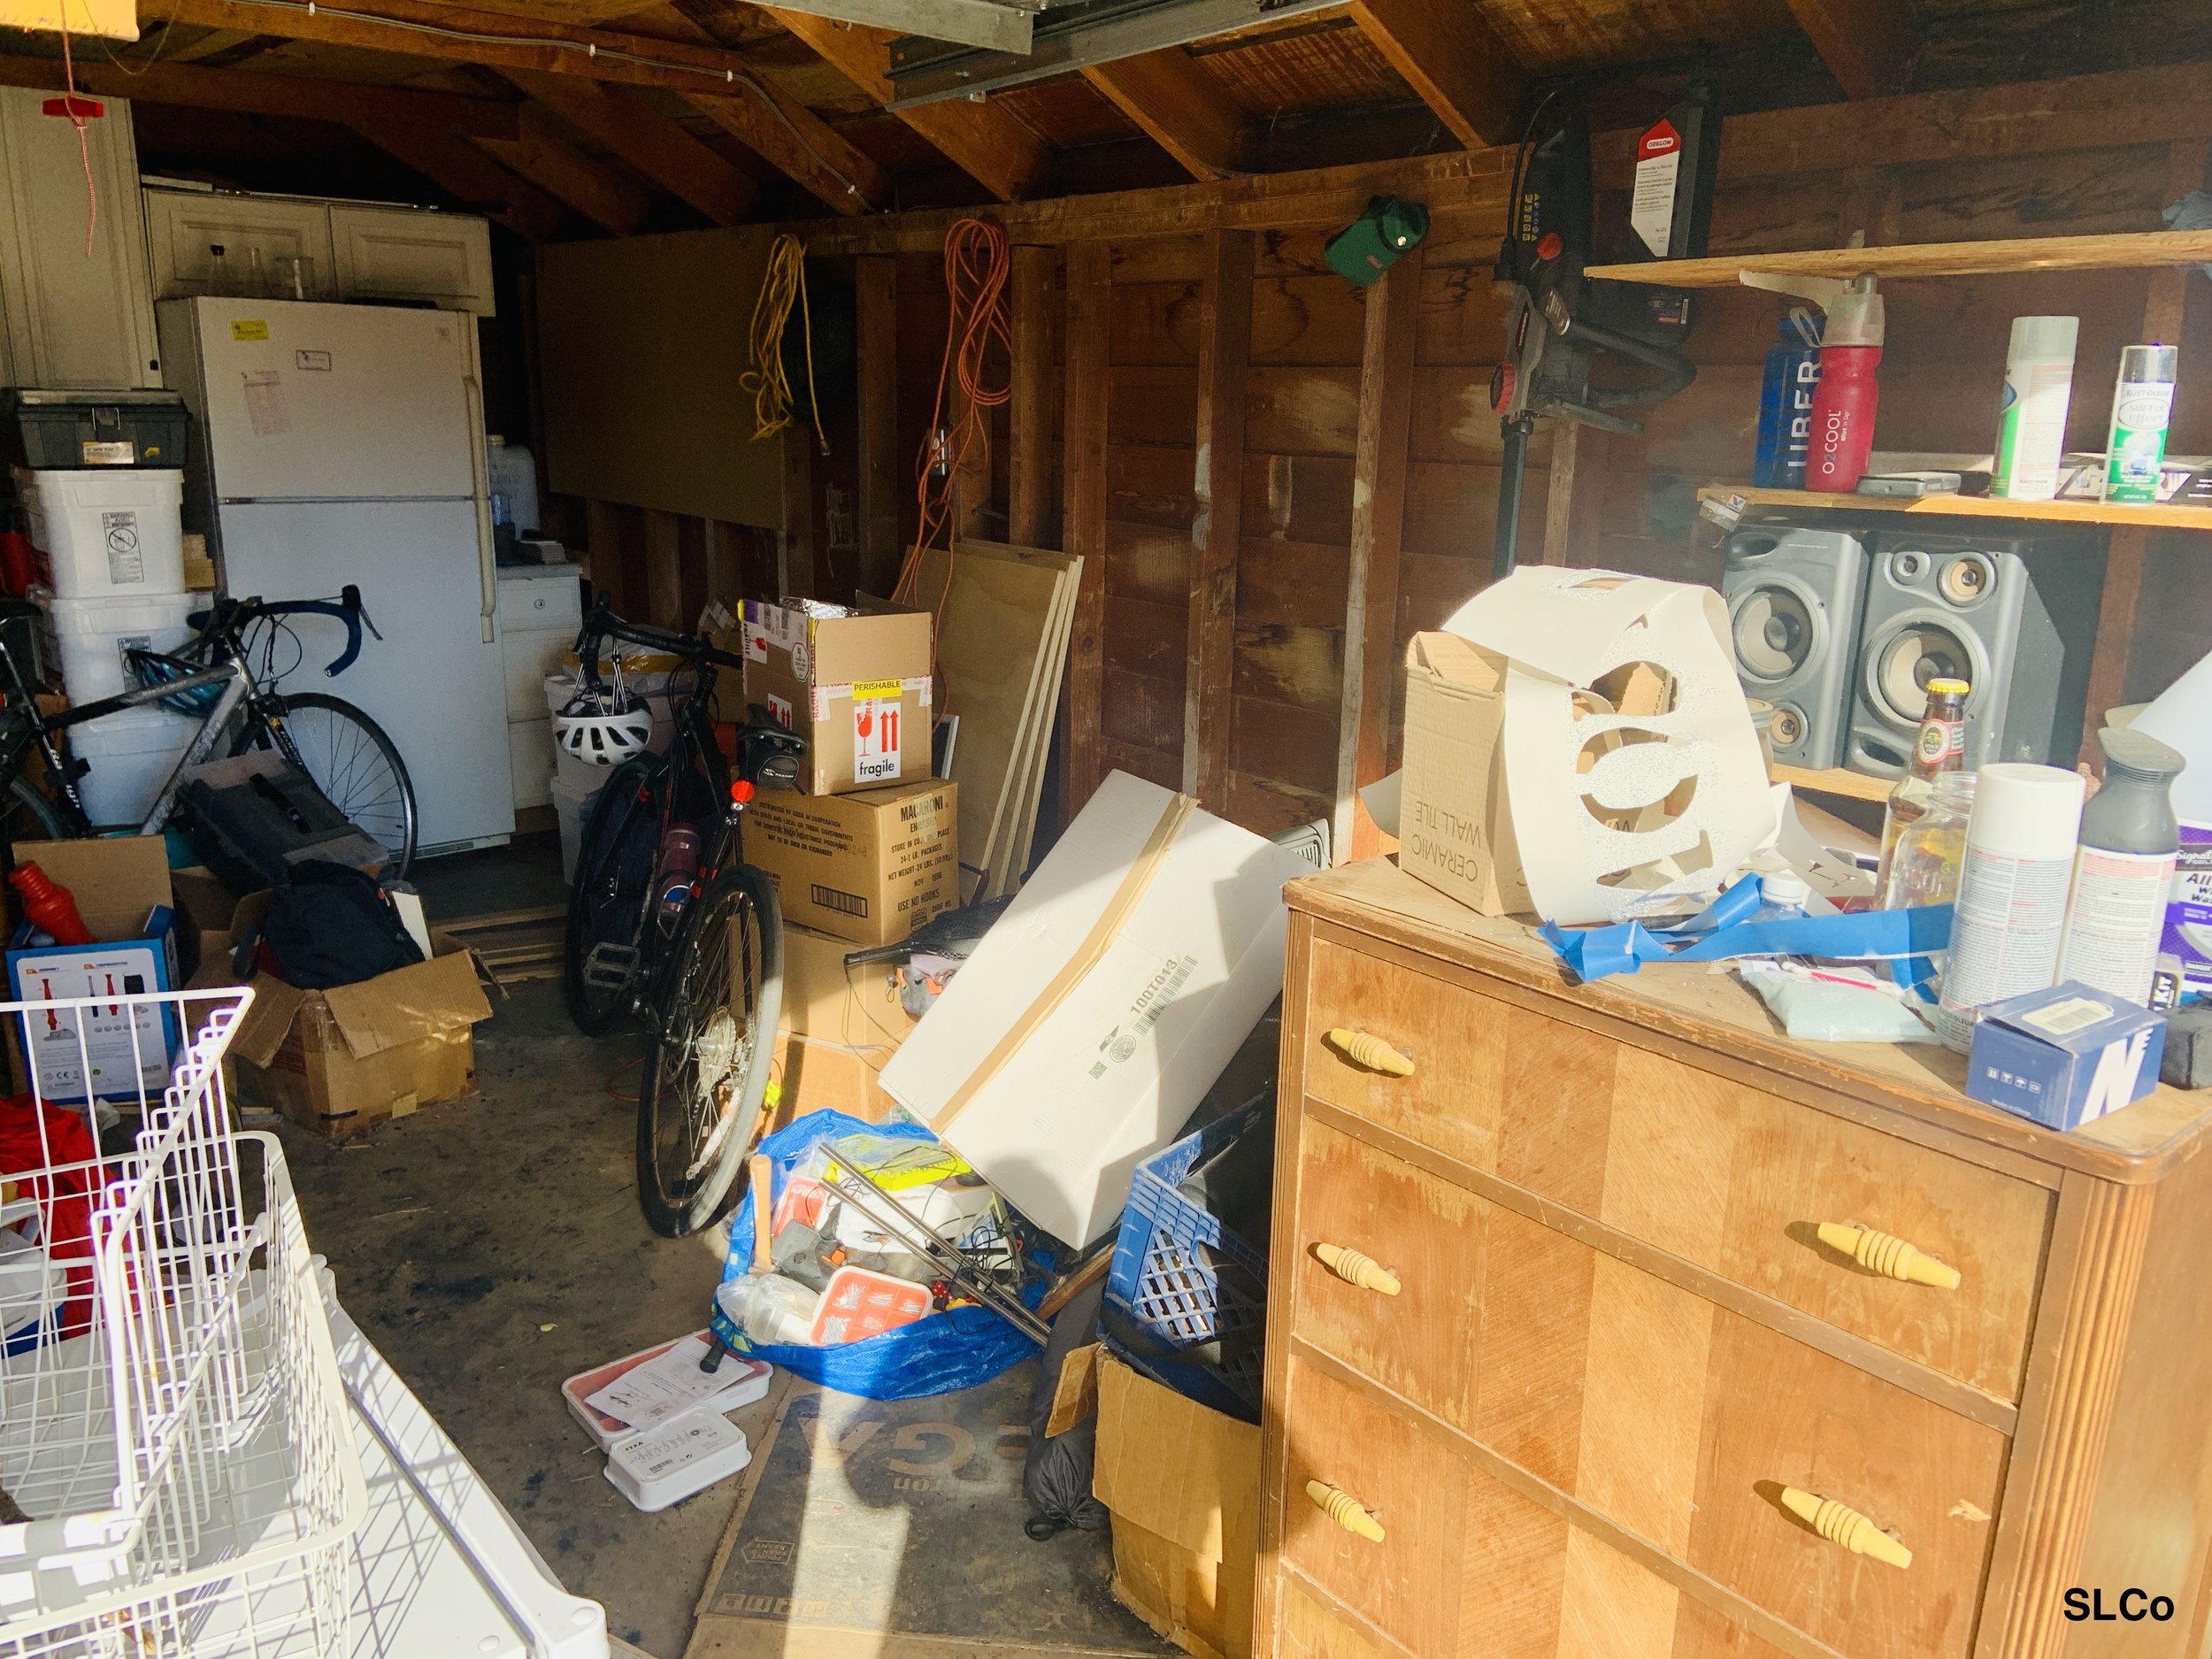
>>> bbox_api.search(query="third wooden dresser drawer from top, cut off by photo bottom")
[1274,1361,1814,1659]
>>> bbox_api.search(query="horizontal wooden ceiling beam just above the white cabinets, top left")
[0,56,522,140]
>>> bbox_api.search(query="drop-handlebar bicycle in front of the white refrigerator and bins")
[0,587,416,874]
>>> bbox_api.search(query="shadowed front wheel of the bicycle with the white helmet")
[560,759,662,1038]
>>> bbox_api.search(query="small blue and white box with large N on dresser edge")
[1967,980,2166,1128]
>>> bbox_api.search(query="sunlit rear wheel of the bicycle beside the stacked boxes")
[637,865,783,1239]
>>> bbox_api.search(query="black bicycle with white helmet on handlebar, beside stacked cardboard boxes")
[562,595,805,1239]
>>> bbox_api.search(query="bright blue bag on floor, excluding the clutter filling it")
[712,1110,1044,1401]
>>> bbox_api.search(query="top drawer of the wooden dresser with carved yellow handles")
[1305,941,2055,1401]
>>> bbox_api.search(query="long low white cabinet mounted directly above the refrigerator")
[146,186,494,317]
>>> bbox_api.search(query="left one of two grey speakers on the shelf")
[1721,525,1867,768]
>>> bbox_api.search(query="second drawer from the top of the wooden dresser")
[1277,1119,2007,1659]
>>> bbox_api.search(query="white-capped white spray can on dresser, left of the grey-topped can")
[1936,761,2082,1053]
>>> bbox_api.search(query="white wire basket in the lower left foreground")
[0,989,367,1659]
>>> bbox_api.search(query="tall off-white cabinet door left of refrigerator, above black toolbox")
[0,87,162,388]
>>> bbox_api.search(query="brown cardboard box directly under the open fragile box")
[746,779,960,945]
